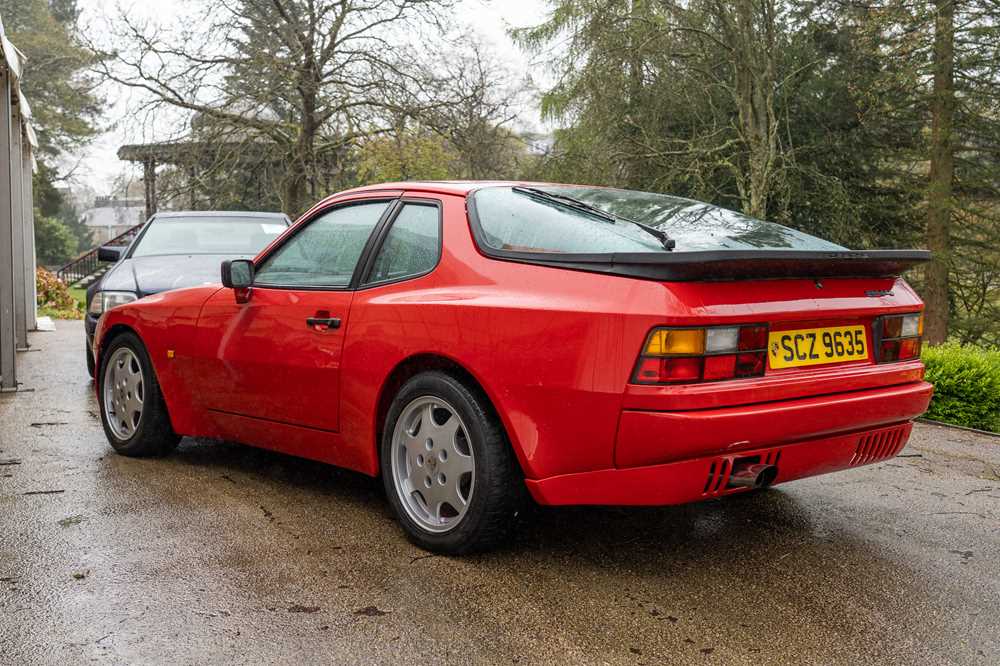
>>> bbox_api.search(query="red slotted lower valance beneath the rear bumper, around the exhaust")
[526,422,913,506]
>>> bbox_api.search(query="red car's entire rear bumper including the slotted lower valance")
[526,381,933,505]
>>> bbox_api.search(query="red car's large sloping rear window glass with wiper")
[473,186,845,254]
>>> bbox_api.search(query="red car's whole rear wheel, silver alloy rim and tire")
[381,371,527,554]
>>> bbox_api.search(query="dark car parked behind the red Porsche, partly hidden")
[84,211,291,377]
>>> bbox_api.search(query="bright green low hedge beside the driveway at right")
[921,343,1000,432]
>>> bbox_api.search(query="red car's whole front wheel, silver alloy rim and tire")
[97,333,180,456]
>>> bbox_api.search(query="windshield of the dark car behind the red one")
[132,215,287,257]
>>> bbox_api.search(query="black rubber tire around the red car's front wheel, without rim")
[97,332,180,457]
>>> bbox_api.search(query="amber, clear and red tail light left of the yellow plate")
[632,324,767,384]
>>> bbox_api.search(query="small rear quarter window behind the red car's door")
[368,204,441,283]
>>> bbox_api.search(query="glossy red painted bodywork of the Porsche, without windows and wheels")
[90,183,931,504]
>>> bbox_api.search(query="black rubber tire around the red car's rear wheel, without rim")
[380,371,528,555]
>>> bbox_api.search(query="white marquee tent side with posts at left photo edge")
[0,17,38,391]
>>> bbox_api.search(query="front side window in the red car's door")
[254,201,389,287]
